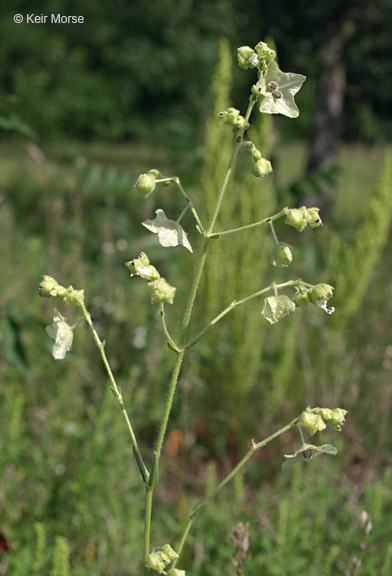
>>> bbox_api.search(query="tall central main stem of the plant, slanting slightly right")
[144,98,255,575]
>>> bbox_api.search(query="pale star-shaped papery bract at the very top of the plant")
[257,62,306,118]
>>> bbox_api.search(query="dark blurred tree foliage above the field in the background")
[0,0,392,145]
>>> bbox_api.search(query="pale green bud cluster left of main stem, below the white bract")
[125,252,176,304]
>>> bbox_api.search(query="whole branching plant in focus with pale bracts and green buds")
[39,42,346,576]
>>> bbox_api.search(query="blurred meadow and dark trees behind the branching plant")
[0,0,392,576]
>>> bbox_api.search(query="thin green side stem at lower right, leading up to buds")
[172,416,300,568]
